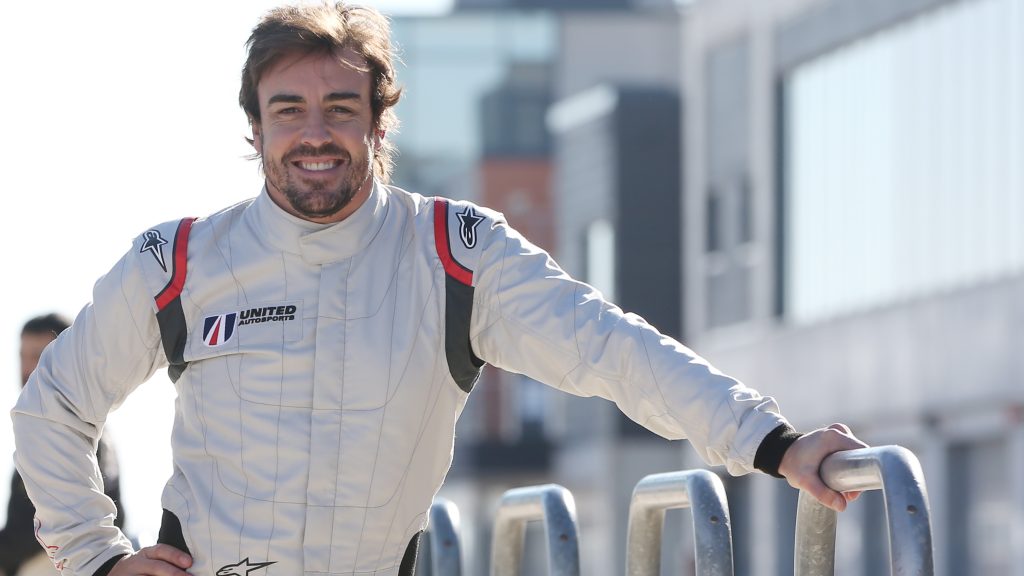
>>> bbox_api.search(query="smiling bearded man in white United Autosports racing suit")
[13,3,863,576]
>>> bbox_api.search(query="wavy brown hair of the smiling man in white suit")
[239,2,401,183]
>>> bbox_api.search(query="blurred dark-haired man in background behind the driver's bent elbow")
[0,314,124,576]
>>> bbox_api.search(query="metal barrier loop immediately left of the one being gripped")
[626,470,732,576]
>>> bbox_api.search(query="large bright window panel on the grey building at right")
[781,0,1024,323]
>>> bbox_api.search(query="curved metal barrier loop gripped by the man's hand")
[795,446,935,576]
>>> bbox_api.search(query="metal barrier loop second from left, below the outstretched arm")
[490,484,580,576]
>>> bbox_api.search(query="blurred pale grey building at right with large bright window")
[671,0,1024,576]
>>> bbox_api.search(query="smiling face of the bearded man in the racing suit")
[253,48,380,222]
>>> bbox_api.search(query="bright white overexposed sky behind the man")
[0,0,452,545]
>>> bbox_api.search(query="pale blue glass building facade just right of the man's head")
[390,11,557,201]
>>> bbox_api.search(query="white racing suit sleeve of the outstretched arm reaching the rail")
[461,208,787,476]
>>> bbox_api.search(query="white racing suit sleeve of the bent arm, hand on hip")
[11,235,167,576]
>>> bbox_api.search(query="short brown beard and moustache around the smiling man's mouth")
[264,142,371,218]
